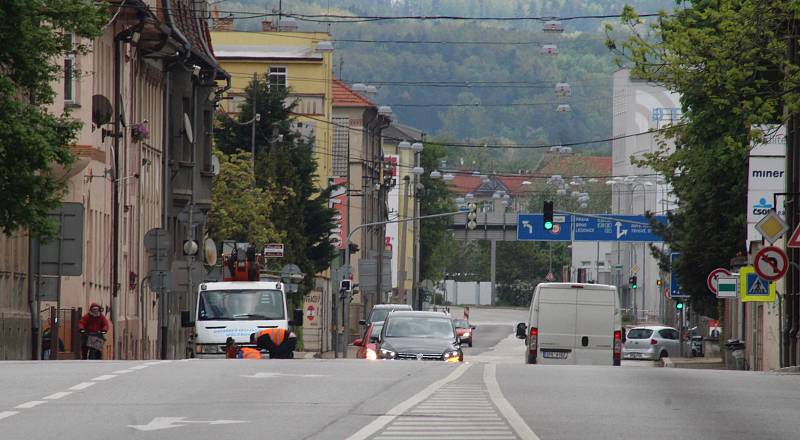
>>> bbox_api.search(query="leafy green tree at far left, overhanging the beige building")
[0,0,108,236]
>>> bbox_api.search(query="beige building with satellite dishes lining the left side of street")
[0,0,225,359]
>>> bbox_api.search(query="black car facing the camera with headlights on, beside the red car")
[377,311,464,362]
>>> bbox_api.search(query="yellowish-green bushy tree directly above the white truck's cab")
[208,150,283,246]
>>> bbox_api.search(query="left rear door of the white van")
[534,285,576,365]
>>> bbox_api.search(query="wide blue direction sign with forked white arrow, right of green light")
[573,215,667,242]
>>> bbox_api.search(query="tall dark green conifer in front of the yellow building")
[215,77,335,288]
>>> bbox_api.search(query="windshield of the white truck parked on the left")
[198,290,285,321]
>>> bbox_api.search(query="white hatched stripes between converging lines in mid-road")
[371,383,519,440]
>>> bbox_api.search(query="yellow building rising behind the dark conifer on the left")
[211,22,333,187]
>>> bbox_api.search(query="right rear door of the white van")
[574,286,616,365]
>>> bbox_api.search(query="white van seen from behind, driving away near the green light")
[517,283,622,365]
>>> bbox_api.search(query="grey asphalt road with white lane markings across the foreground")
[0,306,800,440]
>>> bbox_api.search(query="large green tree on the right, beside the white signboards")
[607,0,800,316]
